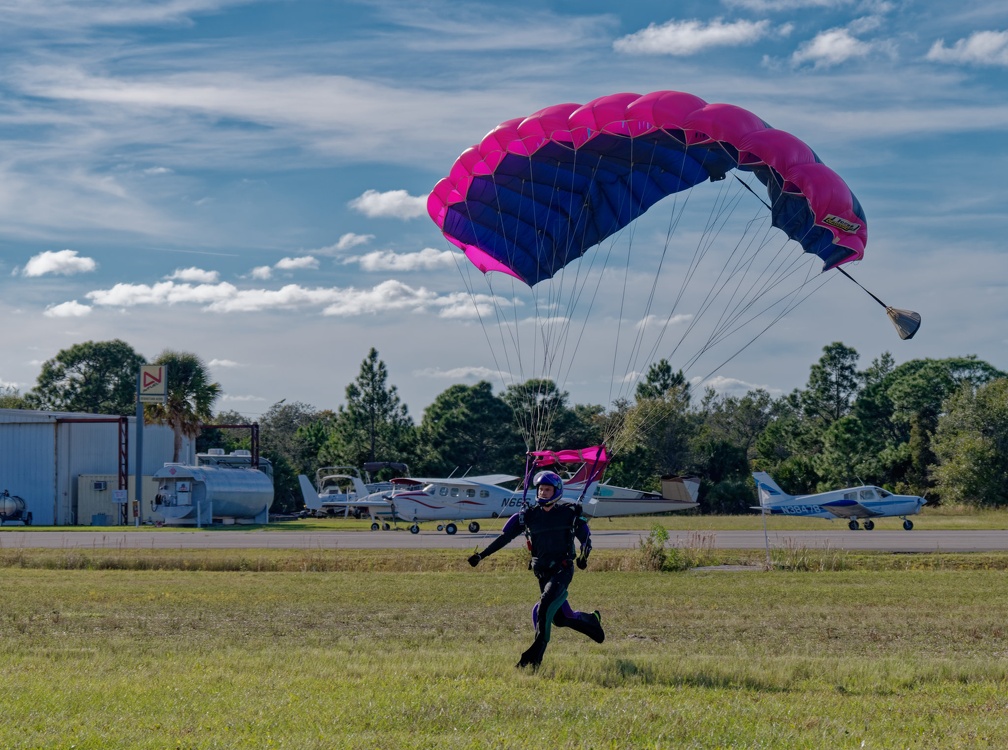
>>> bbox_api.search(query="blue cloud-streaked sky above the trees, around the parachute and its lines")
[0,0,1008,419]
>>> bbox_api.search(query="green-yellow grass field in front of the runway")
[0,549,1008,749]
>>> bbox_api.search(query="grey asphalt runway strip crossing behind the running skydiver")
[0,527,1008,552]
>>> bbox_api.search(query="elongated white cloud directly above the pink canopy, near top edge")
[613,18,771,55]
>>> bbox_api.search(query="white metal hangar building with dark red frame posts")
[0,409,196,526]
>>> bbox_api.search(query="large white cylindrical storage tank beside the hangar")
[154,464,273,525]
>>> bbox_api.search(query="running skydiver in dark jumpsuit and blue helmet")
[469,471,606,669]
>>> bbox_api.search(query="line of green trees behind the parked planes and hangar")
[0,340,1008,513]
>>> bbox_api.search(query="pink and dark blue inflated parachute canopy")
[427,91,868,286]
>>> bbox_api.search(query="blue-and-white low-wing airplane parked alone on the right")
[753,472,927,531]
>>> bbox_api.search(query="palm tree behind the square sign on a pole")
[144,349,221,463]
